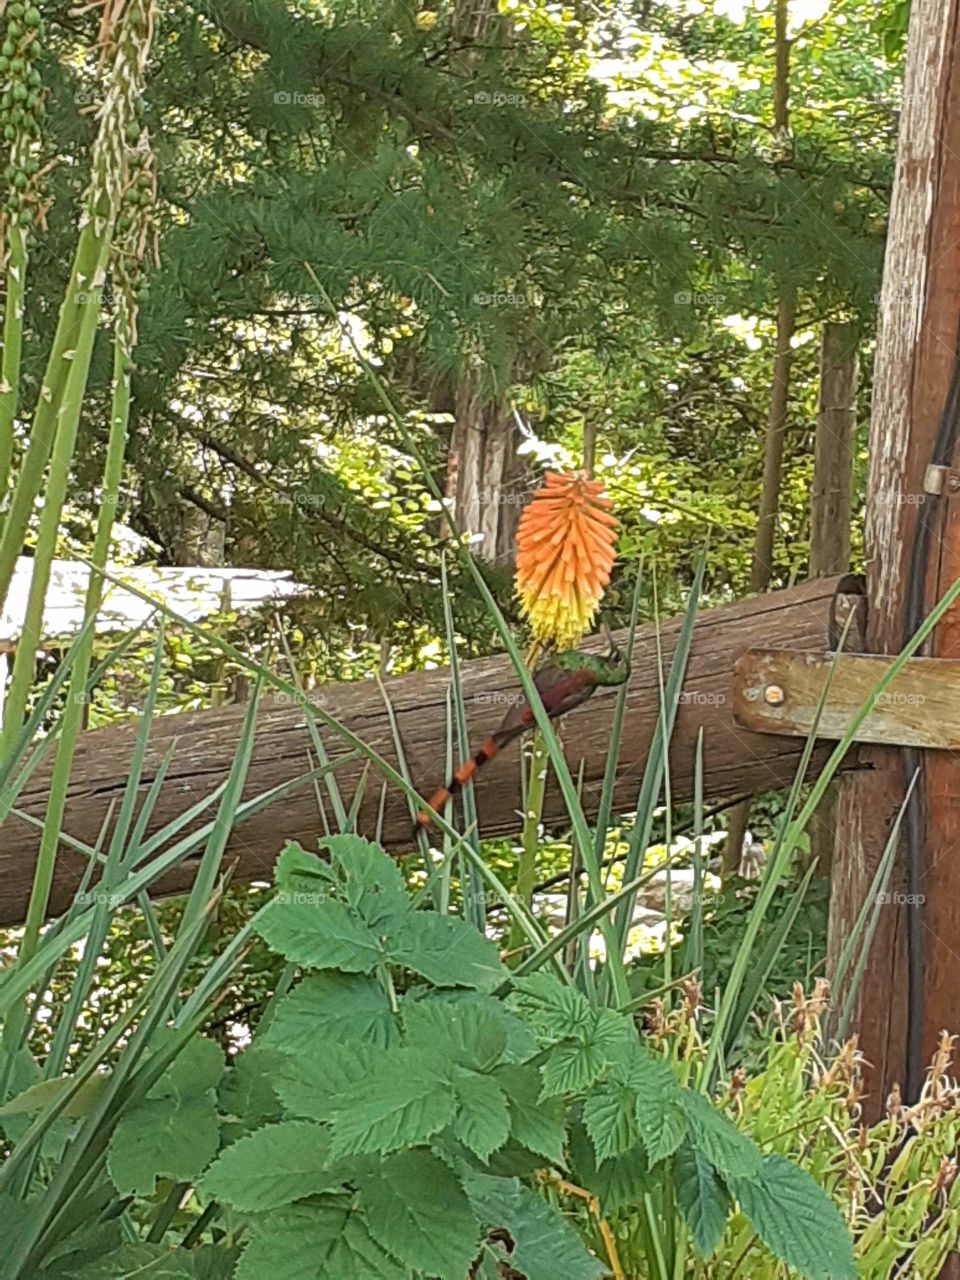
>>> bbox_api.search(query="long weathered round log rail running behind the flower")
[0,577,861,924]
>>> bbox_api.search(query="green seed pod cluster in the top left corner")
[0,0,45,227]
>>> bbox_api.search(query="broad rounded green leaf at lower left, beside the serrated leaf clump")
[106,1096,220,1196]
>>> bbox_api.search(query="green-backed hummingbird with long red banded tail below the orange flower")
[415,626,630,831]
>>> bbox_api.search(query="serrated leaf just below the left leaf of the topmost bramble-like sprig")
[264,972,398,1056]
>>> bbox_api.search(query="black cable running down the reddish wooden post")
[901,332,960,1102]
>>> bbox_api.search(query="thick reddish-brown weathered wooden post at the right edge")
[829,0,960,1131]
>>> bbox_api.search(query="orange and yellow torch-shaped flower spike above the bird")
[517,471,620,648]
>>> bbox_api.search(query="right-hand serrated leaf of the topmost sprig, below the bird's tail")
[389,911,507,991]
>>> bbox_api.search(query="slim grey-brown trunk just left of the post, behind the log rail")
[810,324,860,877]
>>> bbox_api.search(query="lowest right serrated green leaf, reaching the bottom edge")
[726,1156,856,1280]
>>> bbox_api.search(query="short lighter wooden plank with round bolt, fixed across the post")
[733,649,960,751]
